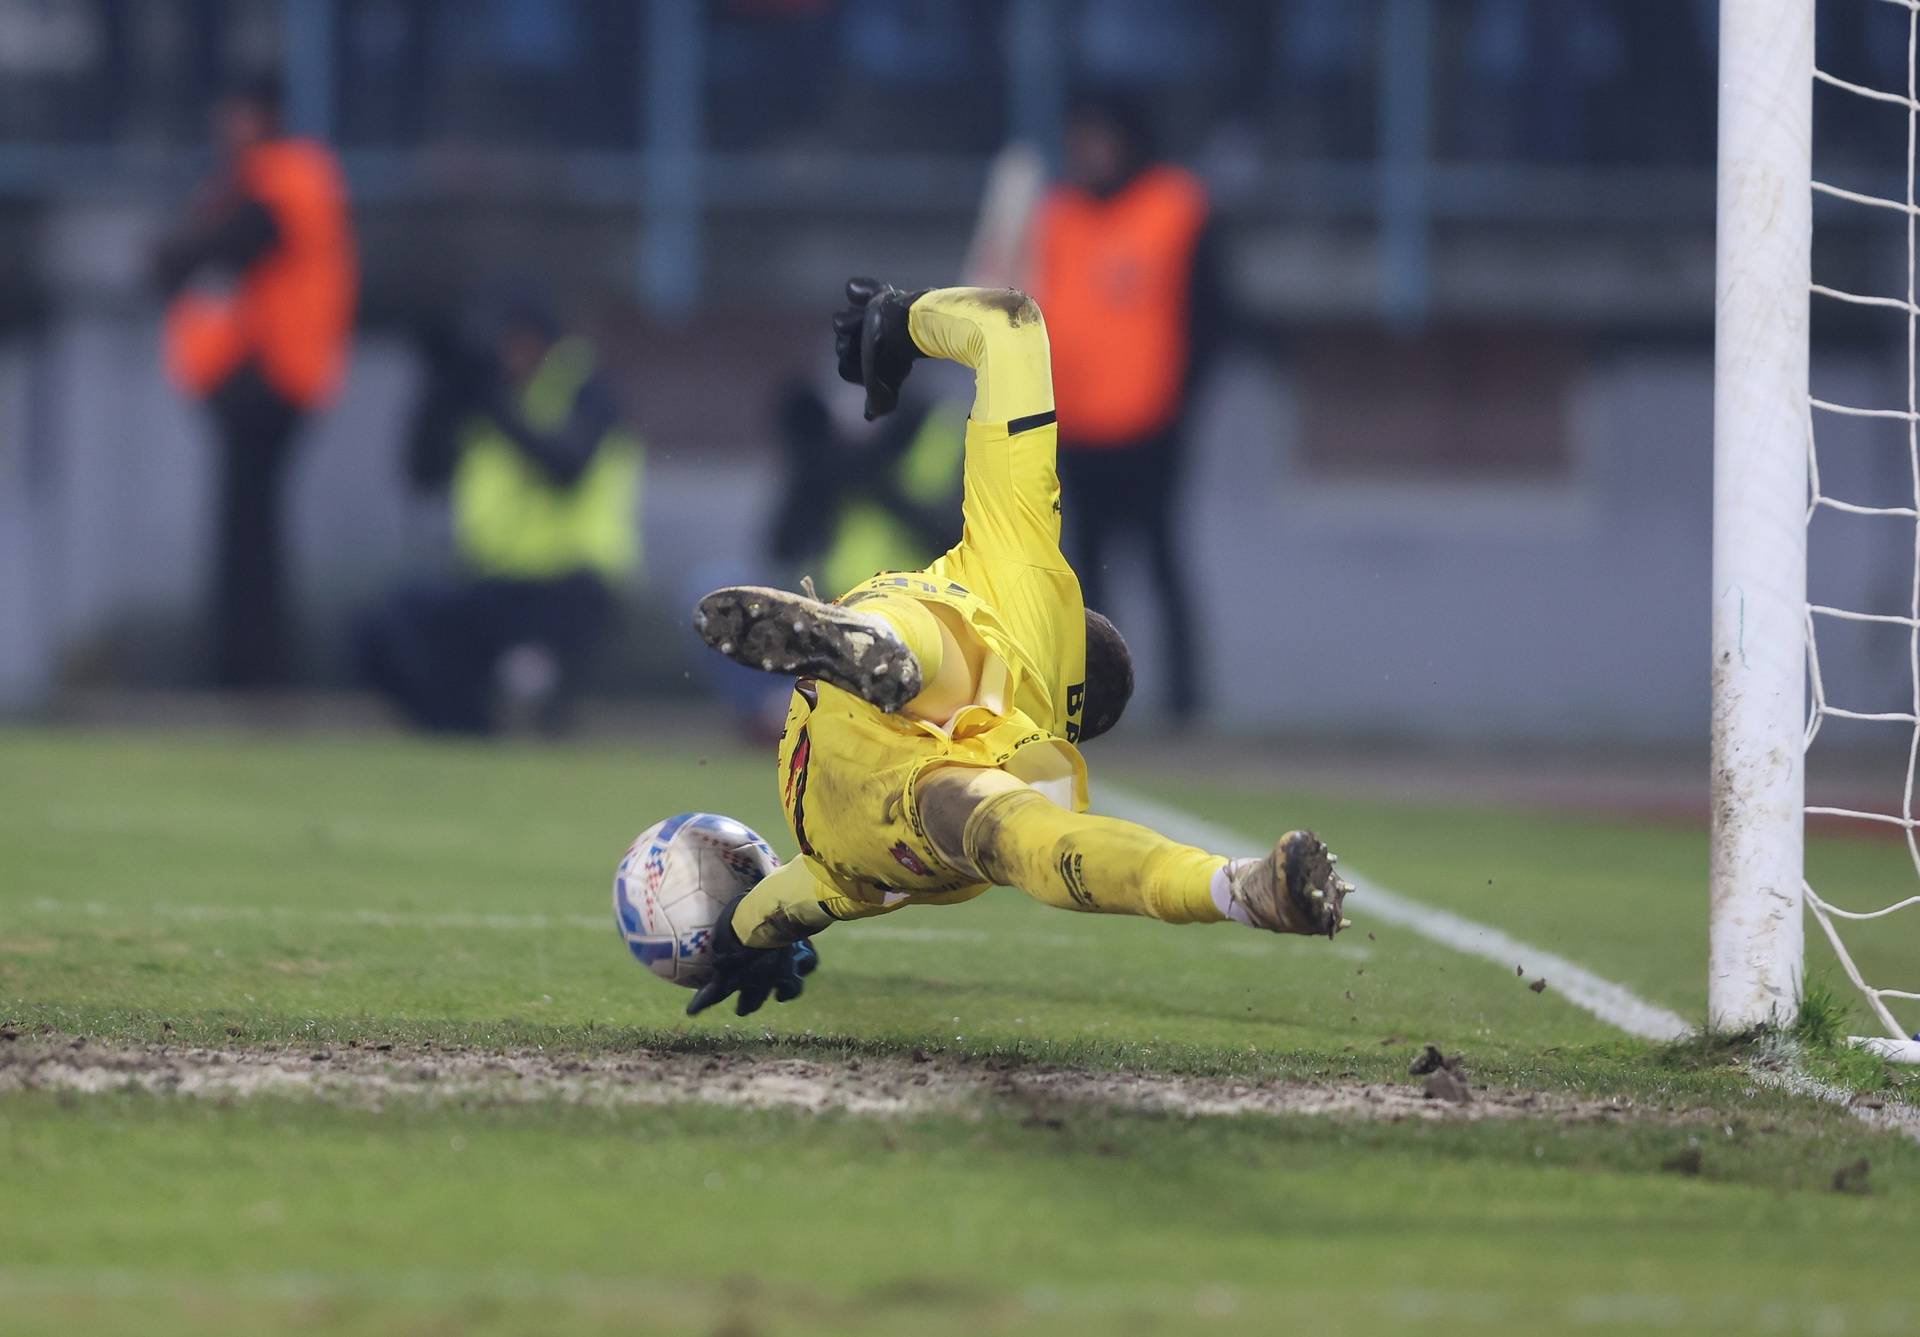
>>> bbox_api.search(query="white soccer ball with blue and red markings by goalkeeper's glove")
[612,813,780,989]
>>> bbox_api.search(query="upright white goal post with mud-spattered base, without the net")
[1707,0,1814,1030]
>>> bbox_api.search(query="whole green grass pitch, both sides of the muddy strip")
[0,732,1920,1335]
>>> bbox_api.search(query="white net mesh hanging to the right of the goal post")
[1807,0,1920,1039]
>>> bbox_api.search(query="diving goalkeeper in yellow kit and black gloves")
[687,279,1350,1014]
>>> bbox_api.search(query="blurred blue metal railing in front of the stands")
[0,0,1758,327]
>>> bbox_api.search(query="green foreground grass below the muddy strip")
[0,1099,1920,1333]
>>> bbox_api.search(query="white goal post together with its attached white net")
[1707,0,1920,1060]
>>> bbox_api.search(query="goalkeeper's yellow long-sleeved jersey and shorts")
[780,288,1087,901]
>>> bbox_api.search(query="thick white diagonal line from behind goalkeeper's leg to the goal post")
[1100,784,1693,1039]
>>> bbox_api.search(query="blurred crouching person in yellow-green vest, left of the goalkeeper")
[355,296,641,734]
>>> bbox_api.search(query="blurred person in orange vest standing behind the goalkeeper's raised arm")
[1029,100,1223,720]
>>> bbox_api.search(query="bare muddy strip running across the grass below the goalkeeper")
[0,1035,1670,1122]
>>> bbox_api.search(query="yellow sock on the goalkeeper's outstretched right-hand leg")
[960,788,1227,924]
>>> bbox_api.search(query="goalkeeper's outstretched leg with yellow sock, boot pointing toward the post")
[918,766,1350,937]
